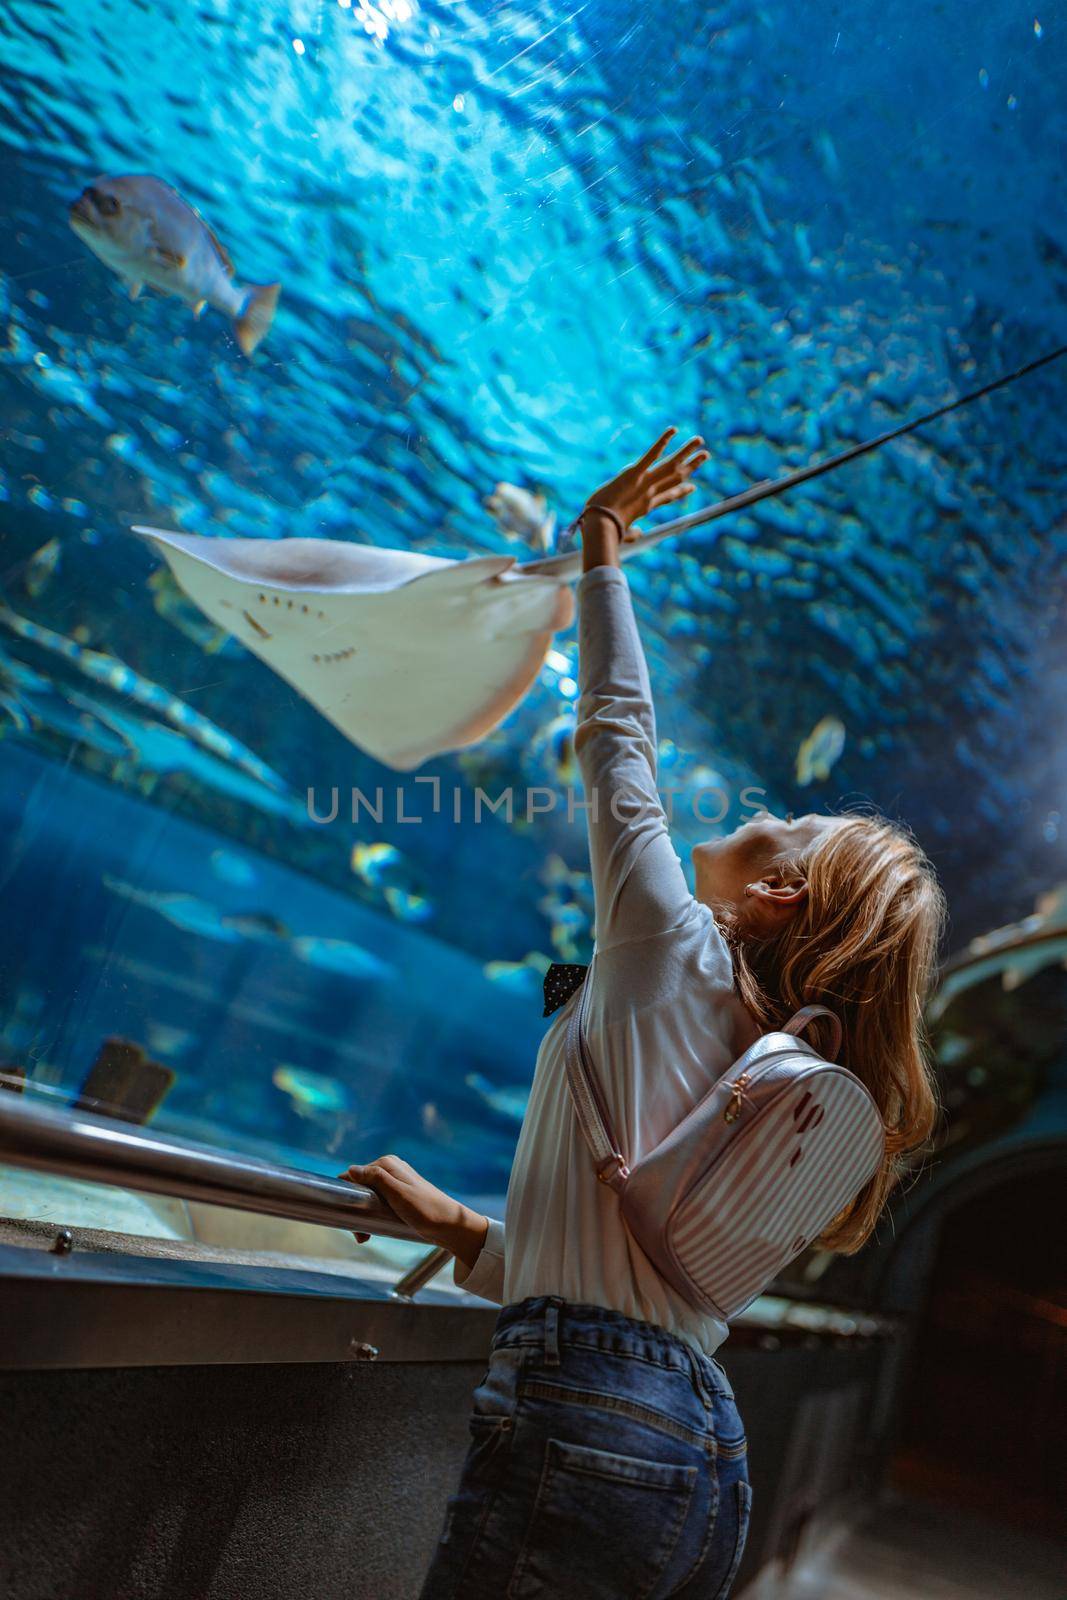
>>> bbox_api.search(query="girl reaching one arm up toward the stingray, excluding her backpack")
[347,429,942,1600]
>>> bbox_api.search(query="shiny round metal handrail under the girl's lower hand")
[0,1093,451,1299]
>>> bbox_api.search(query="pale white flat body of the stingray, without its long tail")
[134,528,574,771]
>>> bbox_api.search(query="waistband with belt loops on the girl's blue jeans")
[493,1294,734,1400]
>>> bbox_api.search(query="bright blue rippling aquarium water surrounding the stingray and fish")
[0,0,1067,1192]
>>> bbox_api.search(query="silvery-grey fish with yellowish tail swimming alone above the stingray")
[69,173,282,355]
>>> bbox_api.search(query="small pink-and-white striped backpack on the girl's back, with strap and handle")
[566,986,885,1322]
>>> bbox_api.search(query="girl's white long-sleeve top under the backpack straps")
[453,566,757,1355]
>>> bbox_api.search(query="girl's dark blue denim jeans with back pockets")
[421,1294,752,1600]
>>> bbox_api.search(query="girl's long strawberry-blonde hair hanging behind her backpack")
[723,813,945,1256]
